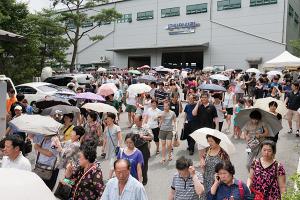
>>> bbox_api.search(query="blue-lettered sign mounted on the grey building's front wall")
[165,22,200,35]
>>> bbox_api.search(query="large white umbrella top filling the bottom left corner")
[0,168,56,200]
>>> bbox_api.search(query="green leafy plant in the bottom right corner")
[282,174,300,200]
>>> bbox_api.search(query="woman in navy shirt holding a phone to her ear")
[207,161,250,200]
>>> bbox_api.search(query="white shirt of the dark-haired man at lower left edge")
[1,152,31,171]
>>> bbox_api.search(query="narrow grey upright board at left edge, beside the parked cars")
[0,80,7,138]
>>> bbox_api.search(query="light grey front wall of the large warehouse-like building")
[68,0,288,68]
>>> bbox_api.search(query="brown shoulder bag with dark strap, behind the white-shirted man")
[33,139,57,180]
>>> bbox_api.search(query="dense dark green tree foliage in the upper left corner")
[0,0,69,84]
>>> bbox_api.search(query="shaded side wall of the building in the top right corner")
[286,0,300,52]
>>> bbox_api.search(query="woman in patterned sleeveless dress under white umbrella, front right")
[200,135,229,197]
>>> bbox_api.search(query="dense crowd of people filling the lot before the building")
[1,67,300,200]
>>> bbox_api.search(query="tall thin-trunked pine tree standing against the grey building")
[52,0,122,71]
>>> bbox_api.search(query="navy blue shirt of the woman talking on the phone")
[207,179,250,200]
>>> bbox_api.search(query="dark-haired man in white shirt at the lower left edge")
[1,135,31,171]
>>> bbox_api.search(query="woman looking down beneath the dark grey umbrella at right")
[242,110,269,170]
